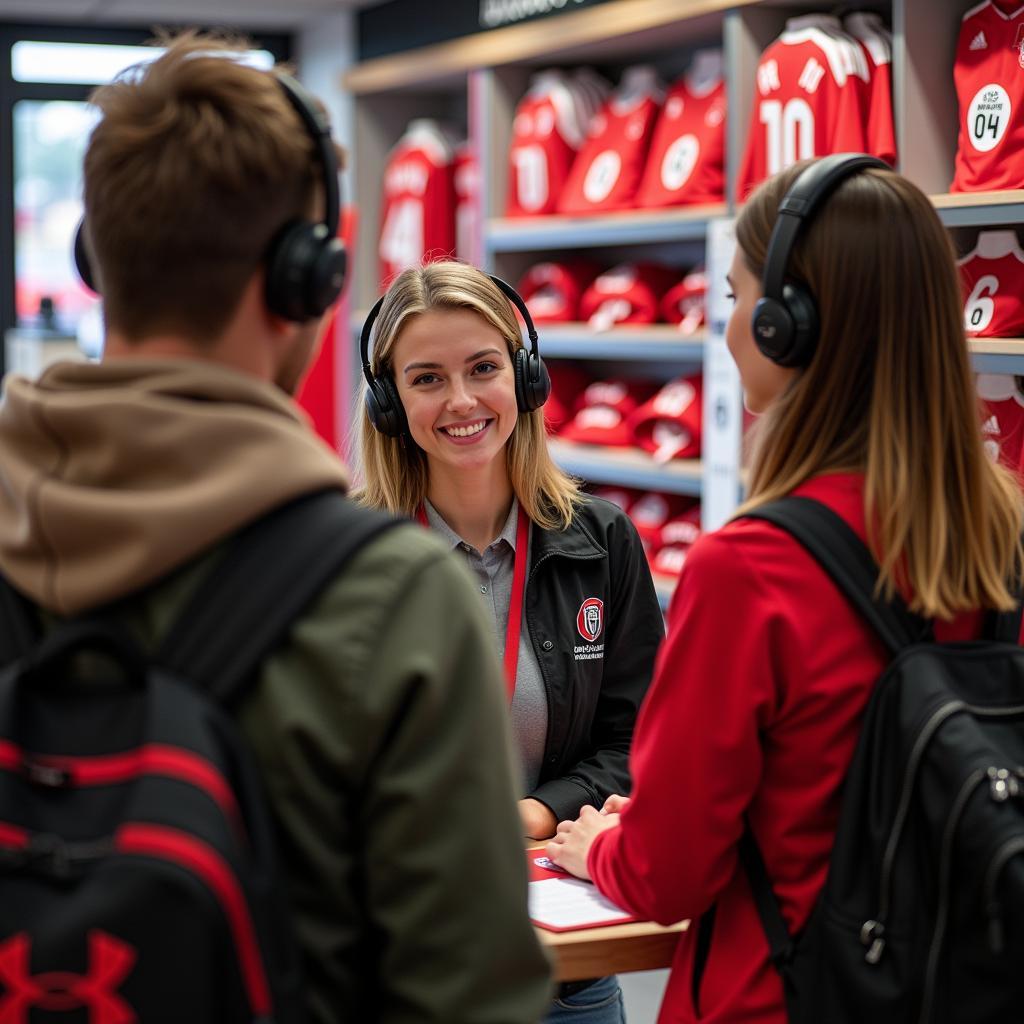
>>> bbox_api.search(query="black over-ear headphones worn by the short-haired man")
[75,73,347,324]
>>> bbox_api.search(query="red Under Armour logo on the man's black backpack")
[0,929,138,1024]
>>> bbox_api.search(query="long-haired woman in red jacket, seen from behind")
[548,157,1022,1024]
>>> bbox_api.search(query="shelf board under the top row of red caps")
[538,324,705,362]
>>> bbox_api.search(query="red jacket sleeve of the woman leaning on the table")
[588,528,796,924]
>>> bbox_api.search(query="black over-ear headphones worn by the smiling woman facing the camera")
[359,274,551,437]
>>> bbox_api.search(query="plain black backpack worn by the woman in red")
[740,498,1024,1024]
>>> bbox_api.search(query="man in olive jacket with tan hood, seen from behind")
[0,35,549,1024]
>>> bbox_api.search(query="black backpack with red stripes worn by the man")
[0,492,396,1024]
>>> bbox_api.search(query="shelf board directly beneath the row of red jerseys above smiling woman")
[483,203,727,253]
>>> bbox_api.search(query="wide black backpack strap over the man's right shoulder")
[155,490,403,705]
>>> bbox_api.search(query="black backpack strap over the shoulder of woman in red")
[743,496,931,654]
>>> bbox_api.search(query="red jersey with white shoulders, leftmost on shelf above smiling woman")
[505,71,585,217]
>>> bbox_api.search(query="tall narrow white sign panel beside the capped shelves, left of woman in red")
[700,218,743,530]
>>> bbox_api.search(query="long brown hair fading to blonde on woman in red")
[736,163,1022,618]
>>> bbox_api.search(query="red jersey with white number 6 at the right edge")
[959,230,1024,338]
